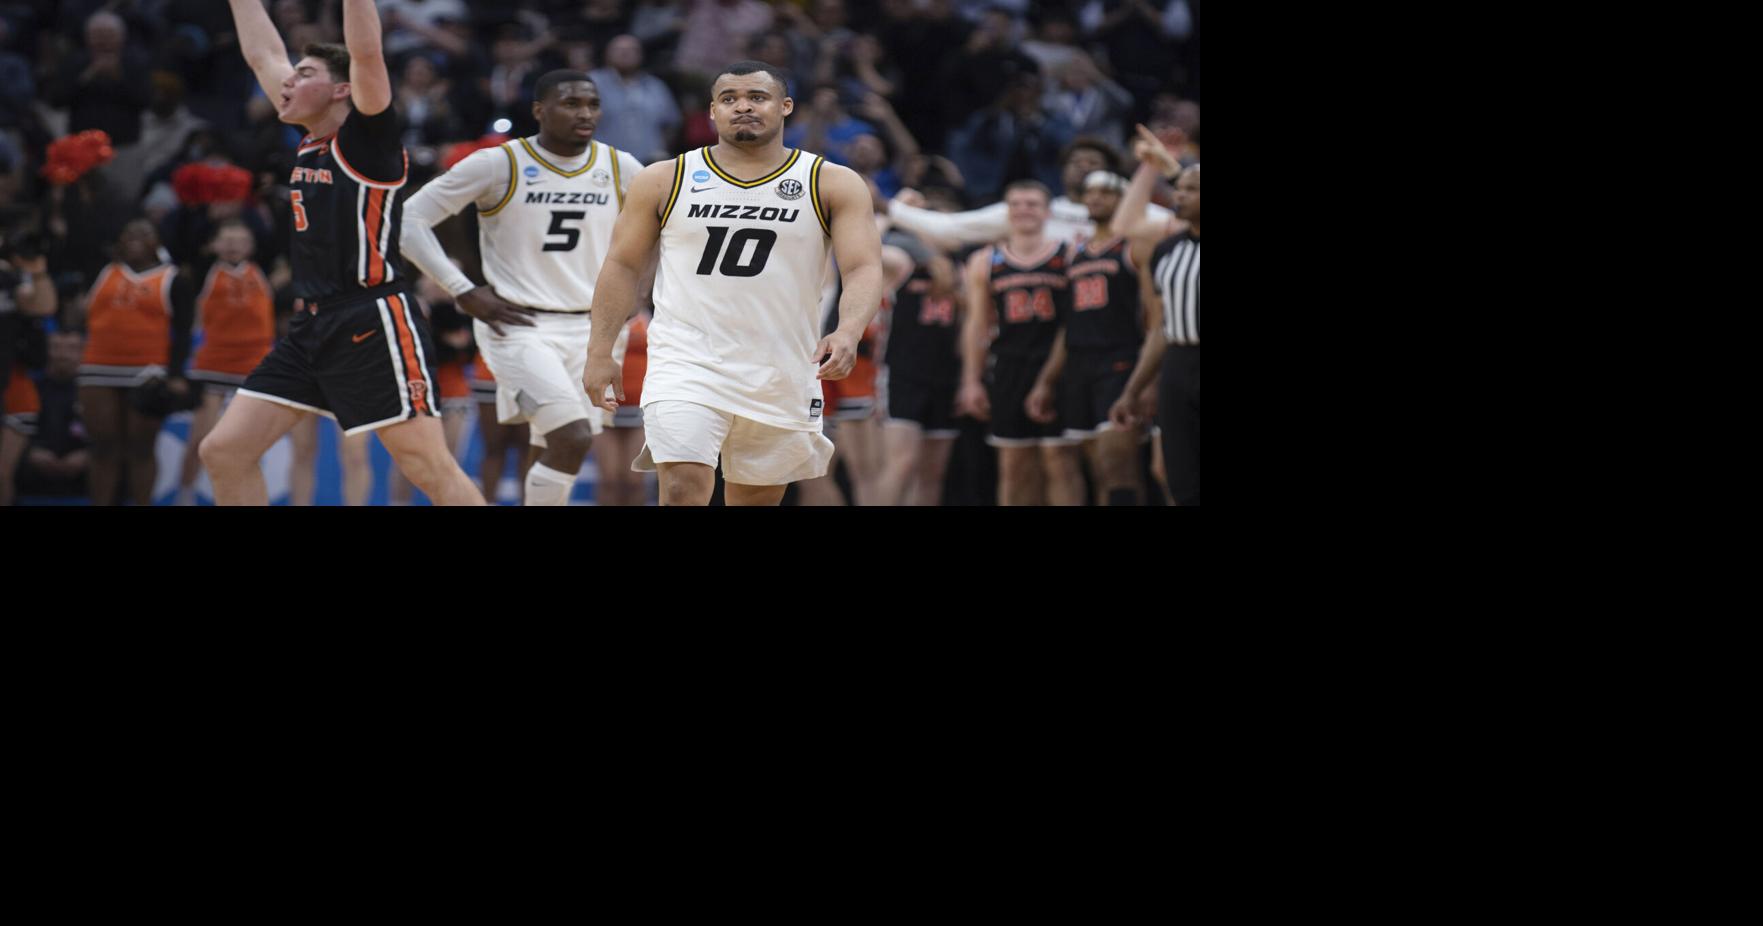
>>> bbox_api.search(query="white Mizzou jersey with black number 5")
[478,138,642,312]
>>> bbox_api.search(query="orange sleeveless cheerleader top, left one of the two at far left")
[81,263,187,367]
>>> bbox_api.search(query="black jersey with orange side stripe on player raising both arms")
[289,106,416,300]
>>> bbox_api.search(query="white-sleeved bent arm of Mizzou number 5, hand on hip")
[398,148,534,337]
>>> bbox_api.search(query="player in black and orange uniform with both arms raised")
[201,0,483,504]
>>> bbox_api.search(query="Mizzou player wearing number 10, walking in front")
[584,62,882,504]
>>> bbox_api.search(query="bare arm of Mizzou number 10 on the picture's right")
[807,164,882,379]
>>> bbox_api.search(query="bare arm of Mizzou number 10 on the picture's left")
[582,161,679,411]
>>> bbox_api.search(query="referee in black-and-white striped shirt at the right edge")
[1109,164,1201,506]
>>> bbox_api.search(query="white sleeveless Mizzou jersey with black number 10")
[643,148,832,430]
